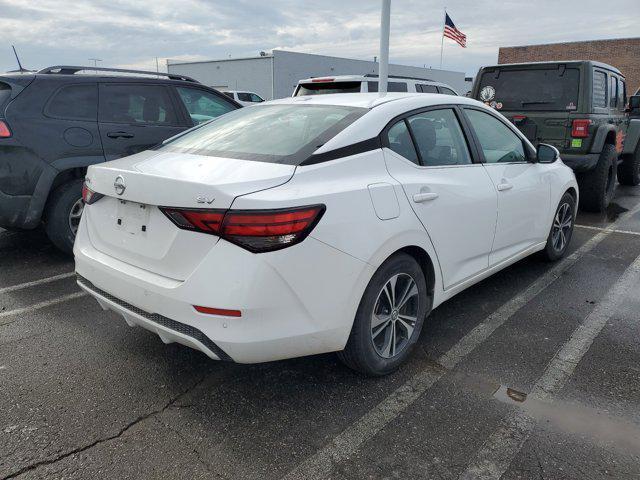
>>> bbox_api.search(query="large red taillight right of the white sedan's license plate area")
[160,205,325,253]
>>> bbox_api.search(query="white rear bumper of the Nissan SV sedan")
[74,218,375,363]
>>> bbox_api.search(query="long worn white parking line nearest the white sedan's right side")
[283,205,640,480]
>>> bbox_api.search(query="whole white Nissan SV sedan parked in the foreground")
[74,94,578,375]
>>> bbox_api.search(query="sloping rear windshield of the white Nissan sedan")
[159,105,368,165]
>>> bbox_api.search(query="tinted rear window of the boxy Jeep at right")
[478,67,580,112]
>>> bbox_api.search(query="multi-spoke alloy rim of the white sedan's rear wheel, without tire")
[371,273,419,358]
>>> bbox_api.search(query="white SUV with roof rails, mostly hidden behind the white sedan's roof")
[292,74,458,97]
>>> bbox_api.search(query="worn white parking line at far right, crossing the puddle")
[460,256,640,480]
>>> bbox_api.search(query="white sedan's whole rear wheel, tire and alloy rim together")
[338,253,432,376]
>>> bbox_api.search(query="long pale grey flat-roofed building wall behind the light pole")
[167,50,469,100]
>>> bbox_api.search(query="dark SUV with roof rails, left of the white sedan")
[0,66,241,252]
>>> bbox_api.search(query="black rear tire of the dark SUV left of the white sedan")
[44,179,82,255]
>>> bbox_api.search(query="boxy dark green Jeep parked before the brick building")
[471,60,640,212]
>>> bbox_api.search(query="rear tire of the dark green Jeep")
[578,144,618,212]
